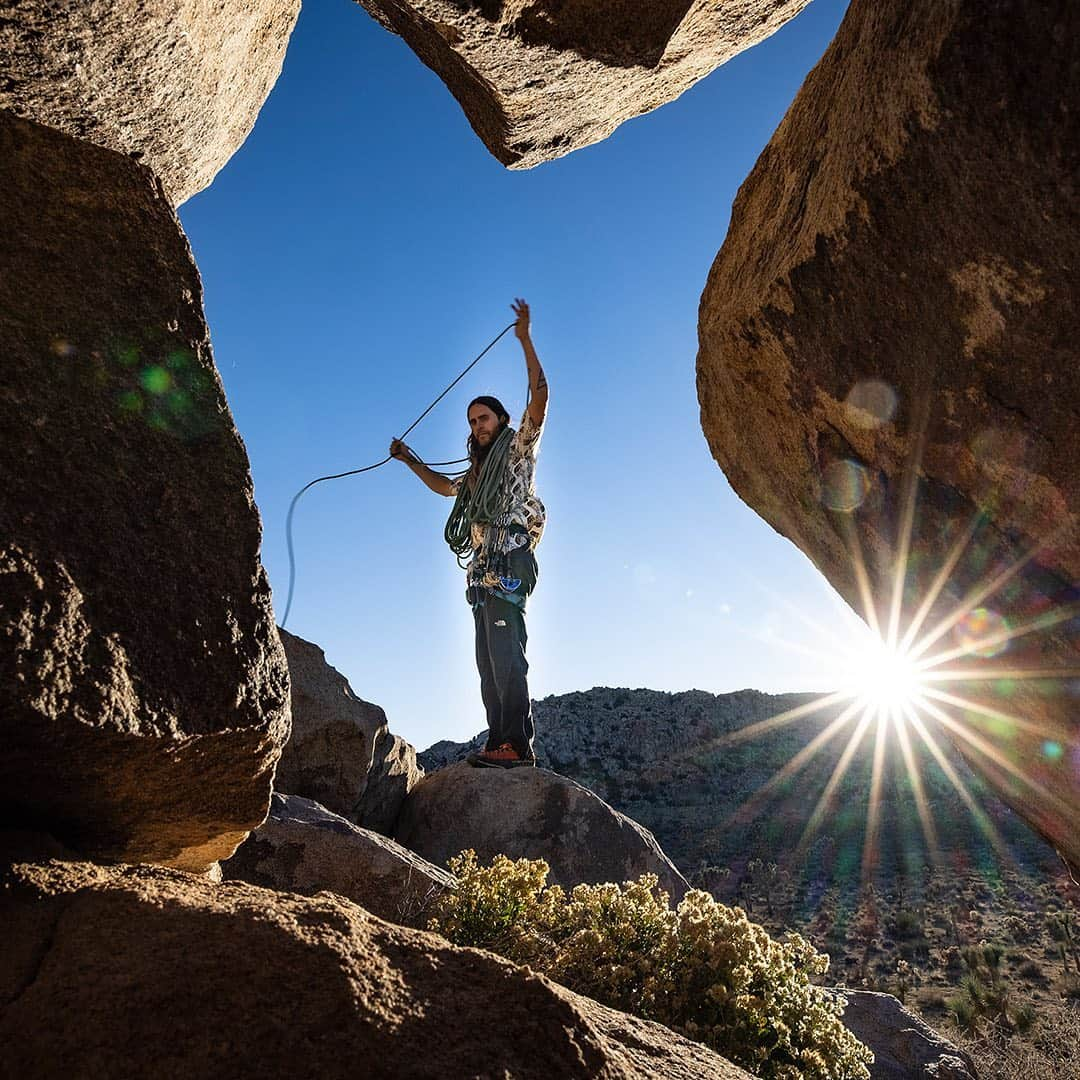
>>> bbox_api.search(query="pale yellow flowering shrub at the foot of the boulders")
[431,851,874,1080]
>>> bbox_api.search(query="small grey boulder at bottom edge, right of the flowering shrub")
[838,989,978,1080]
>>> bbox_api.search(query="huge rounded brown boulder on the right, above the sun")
[698,0,1080,867]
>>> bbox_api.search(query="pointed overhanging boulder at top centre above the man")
[360,0,809,168]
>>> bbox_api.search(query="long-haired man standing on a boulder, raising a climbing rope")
[390,299,548,769]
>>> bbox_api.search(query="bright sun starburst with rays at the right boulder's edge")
[708,384,1080,879]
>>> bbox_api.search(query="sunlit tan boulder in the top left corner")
[0,0,300,205]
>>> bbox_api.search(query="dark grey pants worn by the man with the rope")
[473,550,537,757]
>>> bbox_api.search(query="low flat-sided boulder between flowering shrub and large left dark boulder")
[221,793,454,928]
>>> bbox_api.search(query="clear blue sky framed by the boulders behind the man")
[180,0,855,747]
